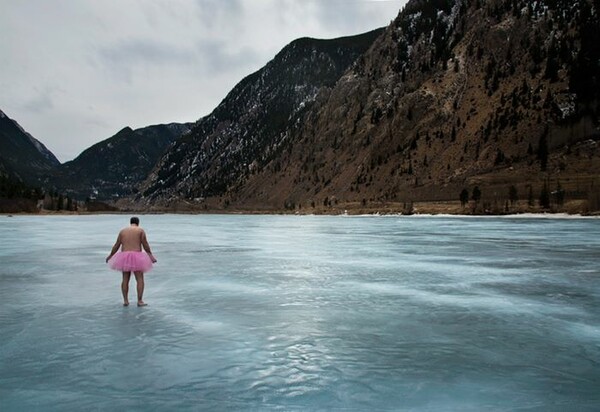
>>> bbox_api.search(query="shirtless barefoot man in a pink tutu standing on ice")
[106,217,156,306]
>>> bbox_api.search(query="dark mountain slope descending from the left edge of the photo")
[0,111,60,185]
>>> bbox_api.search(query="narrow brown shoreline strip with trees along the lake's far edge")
[0,193,600,216]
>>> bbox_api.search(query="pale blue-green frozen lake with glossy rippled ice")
[0,215,600,411]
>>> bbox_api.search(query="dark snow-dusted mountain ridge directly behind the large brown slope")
[142,30,382,204]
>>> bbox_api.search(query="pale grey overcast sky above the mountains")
[0,0,407,162]
